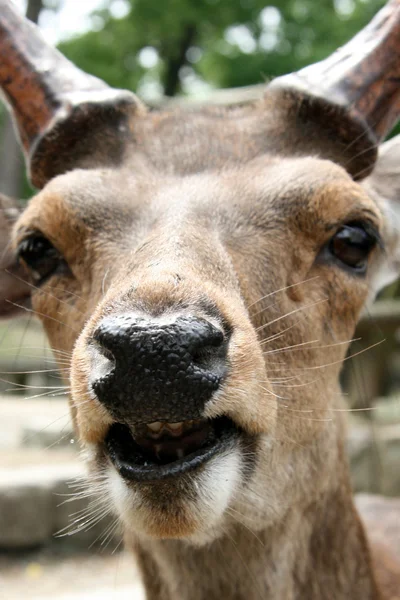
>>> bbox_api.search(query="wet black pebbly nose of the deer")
[91,314,227,424]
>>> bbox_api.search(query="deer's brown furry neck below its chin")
[128,438,380,600]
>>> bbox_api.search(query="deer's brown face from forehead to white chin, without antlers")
[0,0,397,543]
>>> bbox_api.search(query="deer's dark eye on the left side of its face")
[17,235,66,285]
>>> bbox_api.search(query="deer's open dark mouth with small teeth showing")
[104,417,240,482]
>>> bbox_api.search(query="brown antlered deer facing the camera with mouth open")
[0,0,400,600]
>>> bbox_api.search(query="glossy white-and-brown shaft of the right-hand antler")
[270,0,400,177]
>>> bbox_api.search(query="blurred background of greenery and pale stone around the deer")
[0,0,400,600]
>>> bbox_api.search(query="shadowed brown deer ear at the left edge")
[0,194,31,319]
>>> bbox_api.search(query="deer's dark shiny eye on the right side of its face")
[328,223,379,274]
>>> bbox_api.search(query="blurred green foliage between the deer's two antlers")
[60,0,385,97]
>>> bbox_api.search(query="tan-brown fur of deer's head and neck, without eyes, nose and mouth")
[3,4,400,600]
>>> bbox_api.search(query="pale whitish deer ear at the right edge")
[361,135,400,295]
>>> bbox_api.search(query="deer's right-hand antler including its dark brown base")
[267,0,400,180]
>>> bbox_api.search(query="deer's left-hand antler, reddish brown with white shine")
[0,0,144,187]
